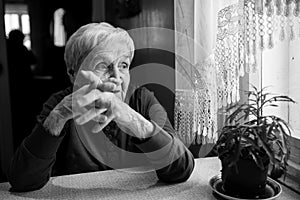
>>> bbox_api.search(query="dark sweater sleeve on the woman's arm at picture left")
[7,88,70,192]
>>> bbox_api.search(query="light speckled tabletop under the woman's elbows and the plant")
[0,157,300,200]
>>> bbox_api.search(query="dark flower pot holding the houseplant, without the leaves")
[221,157,269,197]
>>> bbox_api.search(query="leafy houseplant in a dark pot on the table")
[216,86,294,197]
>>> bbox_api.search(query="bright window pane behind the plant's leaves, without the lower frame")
[250,34,300,139]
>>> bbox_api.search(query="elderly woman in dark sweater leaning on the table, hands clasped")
[8,23,194,192]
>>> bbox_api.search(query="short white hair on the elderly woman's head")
[64,22,134,75]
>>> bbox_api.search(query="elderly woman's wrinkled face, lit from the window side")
[90,40,131,101]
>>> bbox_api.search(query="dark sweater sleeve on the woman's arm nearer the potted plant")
[132,89,194,183]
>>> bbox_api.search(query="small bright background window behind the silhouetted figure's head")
[4,4,31,49]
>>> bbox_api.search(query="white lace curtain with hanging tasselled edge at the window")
[175,0,300,145]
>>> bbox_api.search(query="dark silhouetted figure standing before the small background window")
[7,30,36,150]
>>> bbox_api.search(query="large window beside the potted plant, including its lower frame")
[249,13,300,191]
